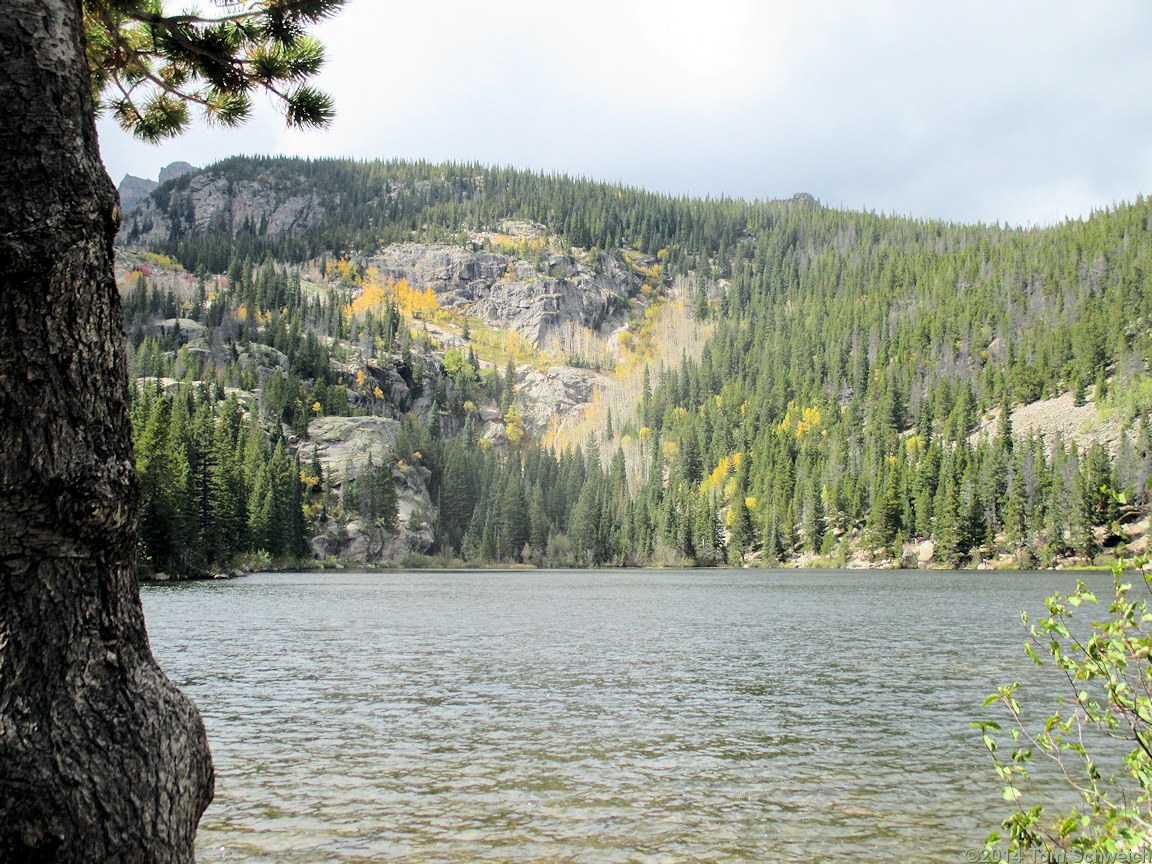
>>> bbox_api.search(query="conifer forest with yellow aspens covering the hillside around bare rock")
[121,158,1152,571]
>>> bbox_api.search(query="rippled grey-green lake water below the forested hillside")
[143,570,1074,864]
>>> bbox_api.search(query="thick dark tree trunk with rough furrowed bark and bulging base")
[0,0,213,862]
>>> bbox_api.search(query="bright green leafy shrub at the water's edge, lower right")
[972,558,1152,855]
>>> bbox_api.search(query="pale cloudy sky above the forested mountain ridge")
[100,0,1152,225]
